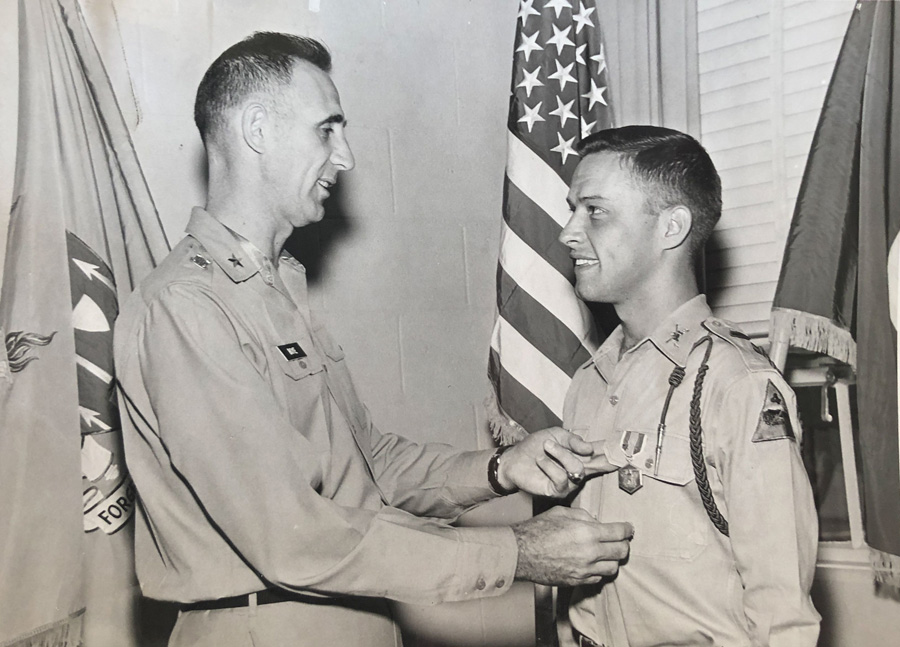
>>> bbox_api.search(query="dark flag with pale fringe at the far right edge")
[771,2,900,588]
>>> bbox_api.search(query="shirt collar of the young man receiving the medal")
[591,294,712,382]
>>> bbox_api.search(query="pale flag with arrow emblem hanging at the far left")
[0,0,168,647]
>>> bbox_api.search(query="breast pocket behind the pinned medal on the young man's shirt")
[601,430,711,560]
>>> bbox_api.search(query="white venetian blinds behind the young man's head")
[697,0,855,336]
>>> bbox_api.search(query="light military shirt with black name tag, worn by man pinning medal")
[115,209,517,613]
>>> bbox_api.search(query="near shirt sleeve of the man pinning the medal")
[136,284,517,603]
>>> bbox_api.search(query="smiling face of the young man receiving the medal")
[559,152,661,305]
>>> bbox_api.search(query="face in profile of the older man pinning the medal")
[263,62,354,227]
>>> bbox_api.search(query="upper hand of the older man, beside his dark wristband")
[497,427,616,497]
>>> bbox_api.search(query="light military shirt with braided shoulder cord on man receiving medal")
[564,295,819,647]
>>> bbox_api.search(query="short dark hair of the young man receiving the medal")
[578,126,722,255]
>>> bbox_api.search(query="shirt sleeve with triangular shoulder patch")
[710,370,820,647]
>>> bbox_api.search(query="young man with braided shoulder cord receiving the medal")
[560,126,819,647]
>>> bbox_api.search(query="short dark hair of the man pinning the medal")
[194,31,331,143]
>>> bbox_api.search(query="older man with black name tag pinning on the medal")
[115,33,631,647]
